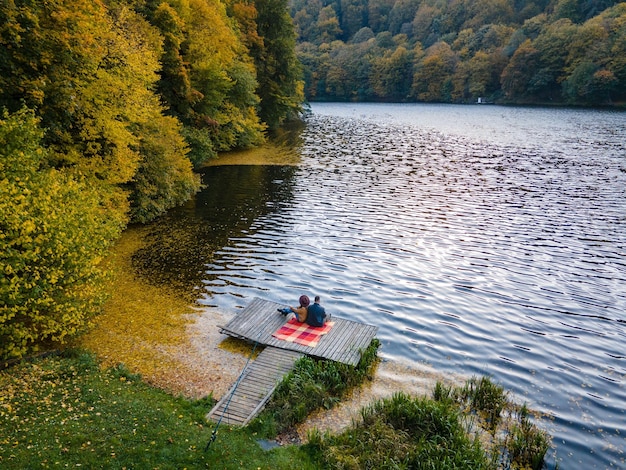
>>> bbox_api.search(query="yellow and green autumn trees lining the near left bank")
[0,0,303,361]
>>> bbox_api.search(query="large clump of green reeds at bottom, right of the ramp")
[307,377,549,470]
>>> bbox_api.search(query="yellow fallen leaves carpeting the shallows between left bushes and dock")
[80,230,193,393]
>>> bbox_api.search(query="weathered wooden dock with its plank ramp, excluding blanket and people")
[207,299,378,426]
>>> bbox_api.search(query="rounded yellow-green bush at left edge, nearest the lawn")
[0,111,122,360]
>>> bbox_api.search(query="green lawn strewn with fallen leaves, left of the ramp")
[0,353,317,469]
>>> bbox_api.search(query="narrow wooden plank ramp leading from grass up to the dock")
[207,347,302,426]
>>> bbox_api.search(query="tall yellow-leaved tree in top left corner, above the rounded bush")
[0,0,140,191]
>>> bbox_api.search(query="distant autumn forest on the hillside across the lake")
[289,0,626,103]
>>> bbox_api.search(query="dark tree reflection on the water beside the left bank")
[133,166,296,301]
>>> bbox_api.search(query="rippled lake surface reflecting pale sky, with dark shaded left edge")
[137,104,626,469]
